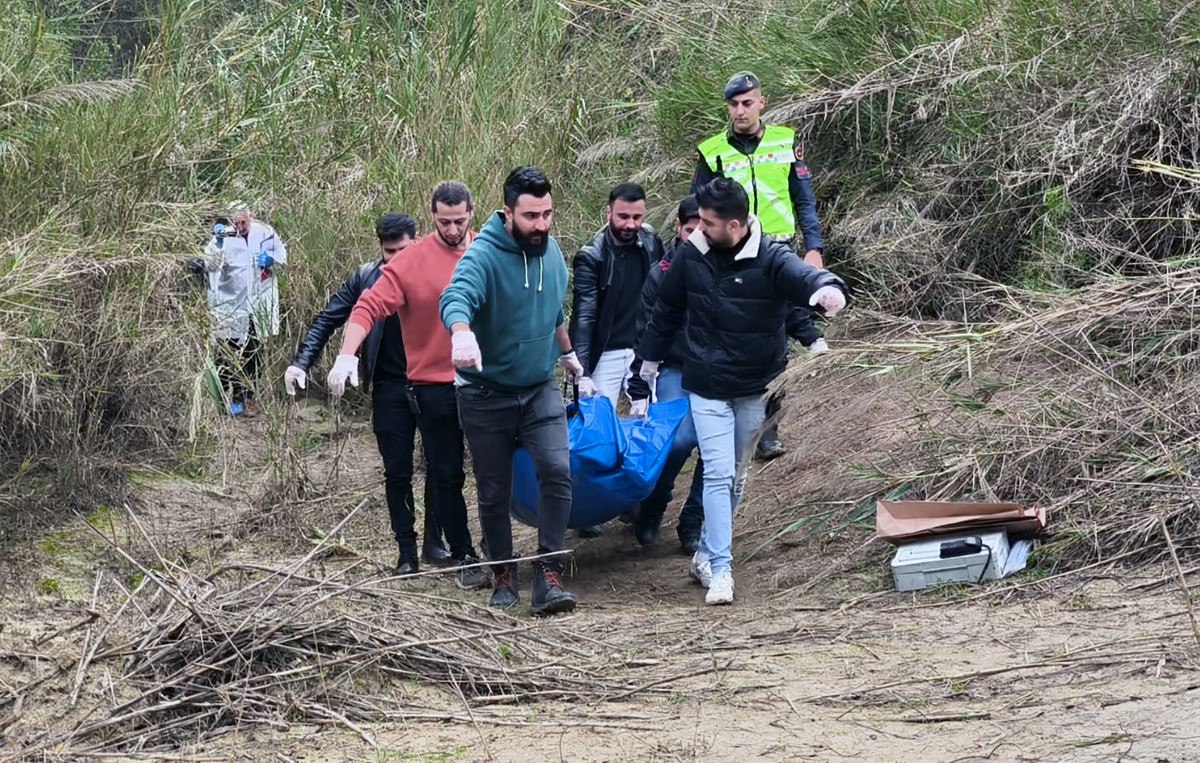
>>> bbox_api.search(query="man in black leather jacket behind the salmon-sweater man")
[283,214,450,575]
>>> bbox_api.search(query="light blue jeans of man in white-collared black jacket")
[690,393,767,572]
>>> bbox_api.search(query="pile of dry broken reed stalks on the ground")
[9,518,719,755]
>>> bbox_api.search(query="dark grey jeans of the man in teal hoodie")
[458,380,571,560]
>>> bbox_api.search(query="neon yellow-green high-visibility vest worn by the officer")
[698,125,796,236]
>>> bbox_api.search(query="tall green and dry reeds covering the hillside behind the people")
[0,0,1200,560]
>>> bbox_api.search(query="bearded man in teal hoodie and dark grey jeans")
[440,167,583,615]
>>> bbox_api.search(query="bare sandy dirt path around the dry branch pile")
[0,403,1200,761]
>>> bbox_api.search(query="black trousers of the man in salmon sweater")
[409,384,475,559]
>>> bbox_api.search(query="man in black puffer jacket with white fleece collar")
[638,178,846,605]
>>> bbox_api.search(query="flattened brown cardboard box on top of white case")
[875,500,1046,543]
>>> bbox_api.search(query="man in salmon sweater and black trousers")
[329,180,492,589]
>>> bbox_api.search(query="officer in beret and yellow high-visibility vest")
[691,72,829,458]
